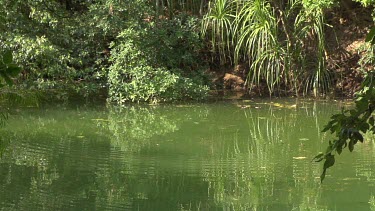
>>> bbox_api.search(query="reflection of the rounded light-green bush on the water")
[106,105,208,152]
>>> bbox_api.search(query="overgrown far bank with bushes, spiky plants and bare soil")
[0,0,375,104]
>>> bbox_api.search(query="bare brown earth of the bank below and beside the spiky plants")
[208,7,375,99]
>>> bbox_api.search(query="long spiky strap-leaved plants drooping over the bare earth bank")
[202,0,333,95]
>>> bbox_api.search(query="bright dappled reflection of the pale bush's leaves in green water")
[103,105,184,152]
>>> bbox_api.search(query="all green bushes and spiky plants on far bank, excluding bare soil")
[0,0,373,103]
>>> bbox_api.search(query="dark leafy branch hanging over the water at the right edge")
[314,29,375,181]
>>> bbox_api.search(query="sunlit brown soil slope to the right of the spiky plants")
[326,7,373,97]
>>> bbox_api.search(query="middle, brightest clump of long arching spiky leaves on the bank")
[235,0,282,93]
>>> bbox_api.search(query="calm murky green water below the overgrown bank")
[0,100,375,211]
